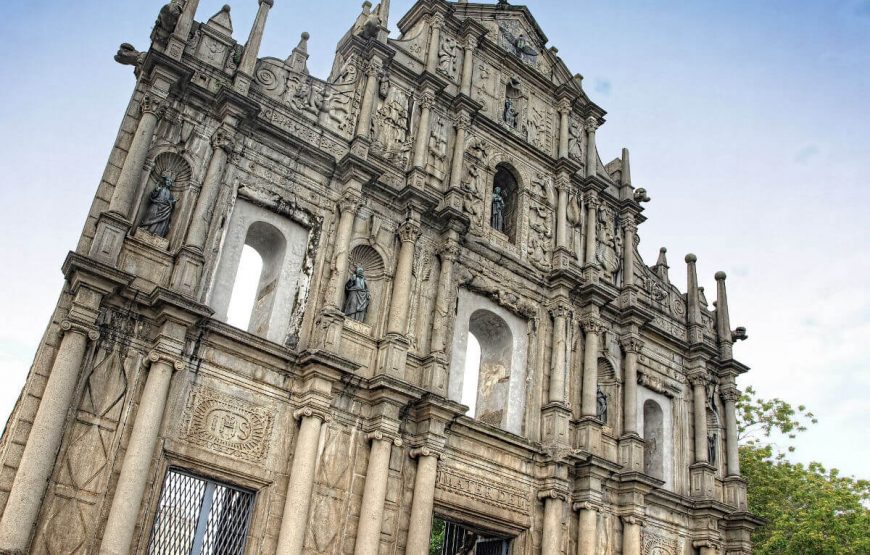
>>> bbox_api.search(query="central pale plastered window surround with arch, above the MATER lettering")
[447,289,528,434]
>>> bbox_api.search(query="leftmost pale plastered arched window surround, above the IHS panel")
[207,199,308,343]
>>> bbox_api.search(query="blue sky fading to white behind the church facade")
[0,0,870,477]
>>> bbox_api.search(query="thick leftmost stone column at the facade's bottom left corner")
[0,320,99,553]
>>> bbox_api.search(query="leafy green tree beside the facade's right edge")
[738,387,870,555]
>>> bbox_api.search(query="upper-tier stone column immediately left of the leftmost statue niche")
[109,94,163,219]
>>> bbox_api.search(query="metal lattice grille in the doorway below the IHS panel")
[148,470,254,555]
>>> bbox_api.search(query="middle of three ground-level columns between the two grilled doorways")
[354,432,401,555]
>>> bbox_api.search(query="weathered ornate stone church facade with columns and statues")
[0,0,758,555]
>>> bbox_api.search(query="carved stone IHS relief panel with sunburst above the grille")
[181,387,275,462]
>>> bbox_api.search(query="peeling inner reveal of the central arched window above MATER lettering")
[468,310,514,426]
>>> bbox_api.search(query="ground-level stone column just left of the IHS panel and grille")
[100,351,184,555]
